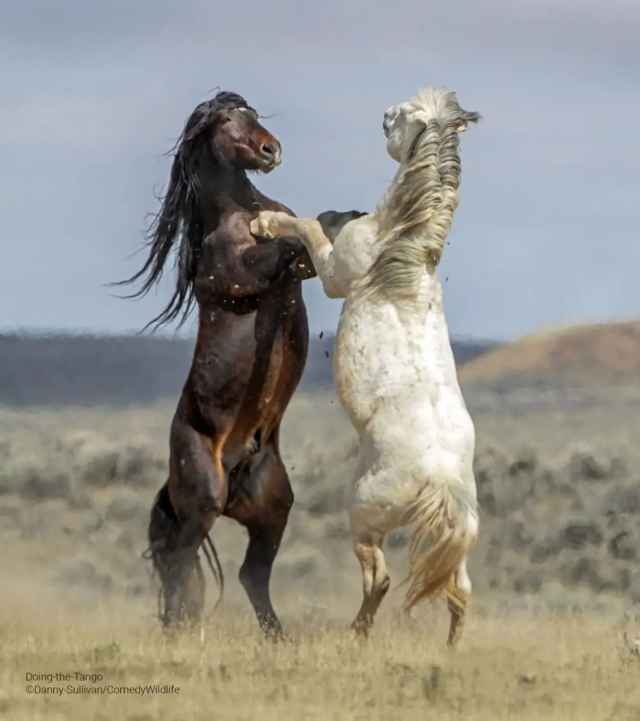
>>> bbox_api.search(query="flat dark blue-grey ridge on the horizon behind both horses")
[0,334,495,406]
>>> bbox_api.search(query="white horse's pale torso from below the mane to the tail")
[334,300,475,522]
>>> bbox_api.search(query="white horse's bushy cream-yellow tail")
[404,481,478,611]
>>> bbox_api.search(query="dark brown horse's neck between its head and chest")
[199,163,261,235]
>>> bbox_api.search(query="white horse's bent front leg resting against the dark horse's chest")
[251,210,347,298]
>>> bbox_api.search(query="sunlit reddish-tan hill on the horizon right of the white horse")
[461,321,640,386]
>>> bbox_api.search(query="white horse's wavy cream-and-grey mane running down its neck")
[362,88,480,301]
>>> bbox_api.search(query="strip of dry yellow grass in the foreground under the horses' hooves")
[5,603,640,721]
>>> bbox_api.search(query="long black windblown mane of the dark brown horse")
[115,92,257,329]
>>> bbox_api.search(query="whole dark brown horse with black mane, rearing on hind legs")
[119,92,314,635]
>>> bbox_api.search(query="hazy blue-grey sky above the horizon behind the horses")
[0,0,640,338]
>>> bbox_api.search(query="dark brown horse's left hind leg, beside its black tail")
[149,419,227,626]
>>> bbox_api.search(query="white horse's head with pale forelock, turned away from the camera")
[382,87,479,163]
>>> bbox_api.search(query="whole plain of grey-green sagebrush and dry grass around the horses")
[0,374,640,721]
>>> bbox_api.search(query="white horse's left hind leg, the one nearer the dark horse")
[351,533,391,636]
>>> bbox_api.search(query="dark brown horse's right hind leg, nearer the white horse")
[226,444,293,638]
